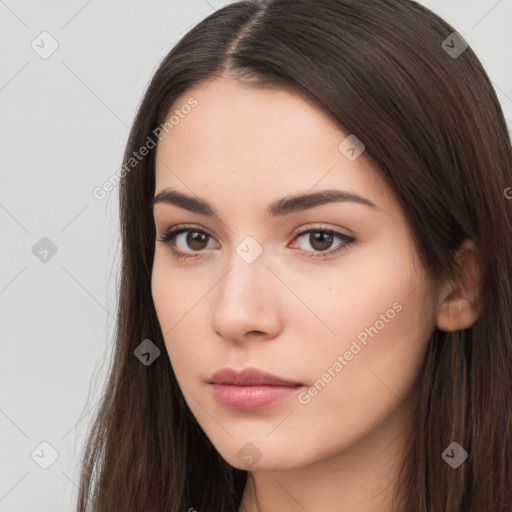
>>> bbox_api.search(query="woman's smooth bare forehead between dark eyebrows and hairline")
[155,78,391,210]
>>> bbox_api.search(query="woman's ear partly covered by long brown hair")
[437,239,483,332]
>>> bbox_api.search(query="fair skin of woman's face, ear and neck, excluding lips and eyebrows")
[151,78,478,512]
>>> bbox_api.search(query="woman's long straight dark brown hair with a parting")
[78,0,512,512]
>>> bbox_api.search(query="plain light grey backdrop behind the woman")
[0,0,512,512]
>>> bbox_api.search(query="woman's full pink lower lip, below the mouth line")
[210,384,302,411]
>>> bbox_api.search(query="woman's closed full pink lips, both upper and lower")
[208,368,302,411]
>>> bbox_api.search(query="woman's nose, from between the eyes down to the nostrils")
[211,251,284,342]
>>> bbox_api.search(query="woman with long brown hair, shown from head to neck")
[78,0,512,512]
